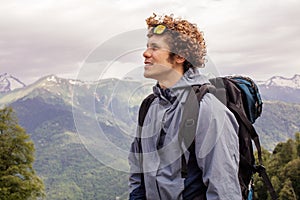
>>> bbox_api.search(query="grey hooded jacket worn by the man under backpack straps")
[129,70,242,200]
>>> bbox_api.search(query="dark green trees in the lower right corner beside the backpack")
[254,132,300,200]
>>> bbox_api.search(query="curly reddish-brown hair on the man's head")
[146,13,206,71]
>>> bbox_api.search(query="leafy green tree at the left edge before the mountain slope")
[0,108,45,200]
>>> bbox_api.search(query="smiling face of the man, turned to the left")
[143,35,174,81]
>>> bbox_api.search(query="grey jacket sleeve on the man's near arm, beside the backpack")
[195,94,242,200]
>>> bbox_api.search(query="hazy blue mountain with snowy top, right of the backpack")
[257,75,300,103]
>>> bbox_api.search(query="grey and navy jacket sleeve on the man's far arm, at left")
[128,128,146,200]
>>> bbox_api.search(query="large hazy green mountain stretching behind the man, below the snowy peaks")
[0,75,300,200]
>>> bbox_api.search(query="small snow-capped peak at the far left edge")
[0,73,26,93]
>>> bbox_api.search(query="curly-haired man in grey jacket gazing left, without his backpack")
[129,14,242,200]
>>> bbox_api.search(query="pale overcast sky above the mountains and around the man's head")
[0,0,300,84]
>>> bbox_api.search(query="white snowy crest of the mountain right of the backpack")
[259,74,300,89]
